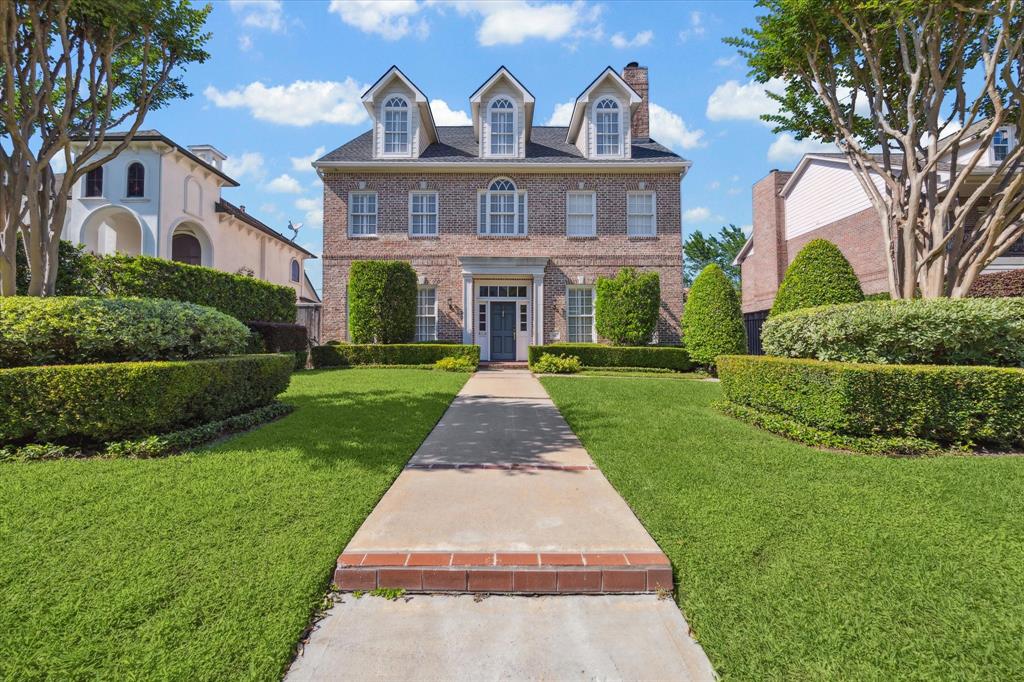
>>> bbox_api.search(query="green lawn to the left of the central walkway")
[0,370,467,680]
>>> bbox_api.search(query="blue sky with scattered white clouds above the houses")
[138,0,831,287]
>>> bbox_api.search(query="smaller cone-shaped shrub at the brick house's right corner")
[683,264,746,370]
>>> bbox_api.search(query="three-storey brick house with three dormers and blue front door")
[313,62,690,360]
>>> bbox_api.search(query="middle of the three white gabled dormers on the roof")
[469,67,536,159]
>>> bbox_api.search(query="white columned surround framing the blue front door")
[459,256,548,361]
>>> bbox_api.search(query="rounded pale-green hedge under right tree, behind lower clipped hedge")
[761,298,1024,367]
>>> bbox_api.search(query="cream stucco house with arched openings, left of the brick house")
[63,130,319,306]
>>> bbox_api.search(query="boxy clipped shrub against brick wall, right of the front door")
[594,267,662,346]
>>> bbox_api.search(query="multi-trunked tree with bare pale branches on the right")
[726,0,1024,298]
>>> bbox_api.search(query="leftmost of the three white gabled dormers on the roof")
[362,67,437,159]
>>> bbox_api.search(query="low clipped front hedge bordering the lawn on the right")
[718,355,1024,447]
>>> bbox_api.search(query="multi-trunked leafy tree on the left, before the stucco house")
[0,0,210,296]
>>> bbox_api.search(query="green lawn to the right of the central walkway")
[543,377,1024,680]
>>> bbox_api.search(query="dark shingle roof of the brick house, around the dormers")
[316,126,685,165]
